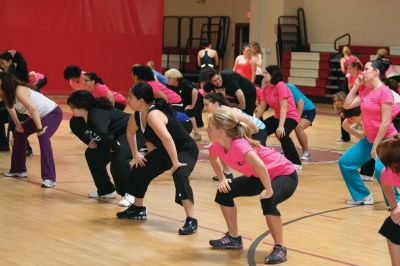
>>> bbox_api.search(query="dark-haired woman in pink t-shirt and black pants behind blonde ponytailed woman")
[256,65,302,170]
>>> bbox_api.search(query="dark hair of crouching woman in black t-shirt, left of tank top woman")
[67,90,113,111]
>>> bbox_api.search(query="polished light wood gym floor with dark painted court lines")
[0,102,390,266]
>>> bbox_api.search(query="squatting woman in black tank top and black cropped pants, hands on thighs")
[117,83,199,235]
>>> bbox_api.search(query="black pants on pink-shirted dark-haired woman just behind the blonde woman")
[263,116,301,165]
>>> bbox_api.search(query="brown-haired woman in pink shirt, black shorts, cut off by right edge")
[377,135,400,265]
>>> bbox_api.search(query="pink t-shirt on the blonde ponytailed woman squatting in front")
[208,139,295,180]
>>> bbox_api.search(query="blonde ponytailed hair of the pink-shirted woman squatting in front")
[208,108,260,147]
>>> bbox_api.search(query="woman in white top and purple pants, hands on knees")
[0,72,63,188]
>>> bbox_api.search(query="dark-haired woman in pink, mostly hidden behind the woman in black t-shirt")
[83,72,126,111]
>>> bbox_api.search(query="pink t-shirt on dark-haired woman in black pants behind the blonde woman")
[263,81,300,122]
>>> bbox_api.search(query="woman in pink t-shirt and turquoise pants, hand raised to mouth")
[339,60,400,205]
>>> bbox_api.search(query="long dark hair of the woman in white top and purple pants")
[0,72,34,108]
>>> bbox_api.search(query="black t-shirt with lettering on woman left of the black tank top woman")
[70,108,130,151]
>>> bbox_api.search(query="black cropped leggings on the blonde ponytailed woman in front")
[215,171,298,213]
